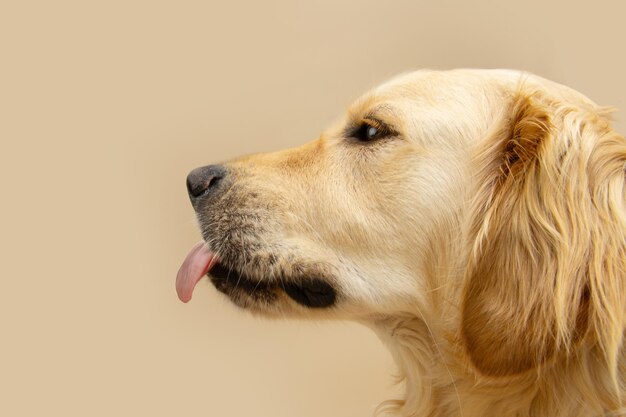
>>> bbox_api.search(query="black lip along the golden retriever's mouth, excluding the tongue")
[208,262,337,308]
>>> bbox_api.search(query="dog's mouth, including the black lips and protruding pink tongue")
[176,242,337,308]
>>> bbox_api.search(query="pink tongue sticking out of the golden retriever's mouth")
[176,242,217,303]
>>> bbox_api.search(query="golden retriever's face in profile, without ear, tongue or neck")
[178,72,496,317]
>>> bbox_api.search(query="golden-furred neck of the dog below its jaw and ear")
[368,313,626,417]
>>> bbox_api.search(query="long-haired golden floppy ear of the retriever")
[461,93,626,378]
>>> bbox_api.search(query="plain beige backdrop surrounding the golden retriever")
[0,0,626,417]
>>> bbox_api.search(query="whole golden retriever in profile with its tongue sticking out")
[176,69,626,417]
